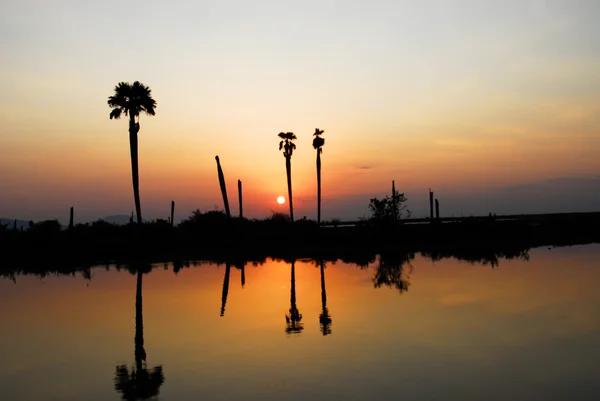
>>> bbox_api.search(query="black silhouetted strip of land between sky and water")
[0,213,600,273]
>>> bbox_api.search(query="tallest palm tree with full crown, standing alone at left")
[108,81,156,224]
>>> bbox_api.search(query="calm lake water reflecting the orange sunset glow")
[0,244,600,401]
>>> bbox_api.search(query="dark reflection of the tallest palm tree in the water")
[114,266,165,401]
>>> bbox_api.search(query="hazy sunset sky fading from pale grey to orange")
[0,0,600,221]
